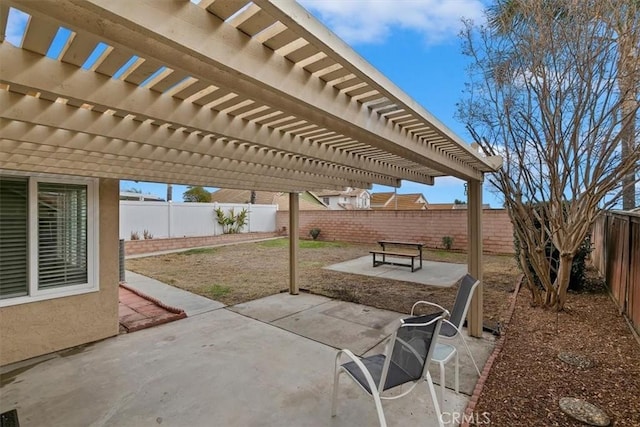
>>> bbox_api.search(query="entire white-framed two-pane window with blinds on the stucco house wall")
[0,172,99,307]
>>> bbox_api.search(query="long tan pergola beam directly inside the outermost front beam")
[0,43,433,185]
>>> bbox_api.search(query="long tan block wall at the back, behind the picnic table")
[276,209,514,254]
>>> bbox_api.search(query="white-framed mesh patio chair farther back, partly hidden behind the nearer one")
[411,274,480,402]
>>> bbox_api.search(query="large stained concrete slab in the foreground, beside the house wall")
[0,309,468,427]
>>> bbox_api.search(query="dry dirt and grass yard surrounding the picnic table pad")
[126,239,518,328]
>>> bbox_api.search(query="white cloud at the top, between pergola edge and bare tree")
[298,0,484,44]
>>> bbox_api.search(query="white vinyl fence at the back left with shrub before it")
[120,200,278,240]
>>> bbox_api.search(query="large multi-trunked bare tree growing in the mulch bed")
[459,0,640,310]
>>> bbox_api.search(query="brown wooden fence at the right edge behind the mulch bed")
[591,212,640,333]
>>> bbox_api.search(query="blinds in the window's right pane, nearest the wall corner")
[38,182,88,290]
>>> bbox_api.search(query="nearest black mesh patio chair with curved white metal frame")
[331,310,448,427]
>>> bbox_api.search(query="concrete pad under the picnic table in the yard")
[326,256,467,288]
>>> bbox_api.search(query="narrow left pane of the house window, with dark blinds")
[0,176,29,299]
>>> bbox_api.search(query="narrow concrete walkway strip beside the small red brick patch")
[125,271,225,316]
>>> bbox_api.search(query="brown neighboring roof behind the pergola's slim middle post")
[211,188,327,211]
